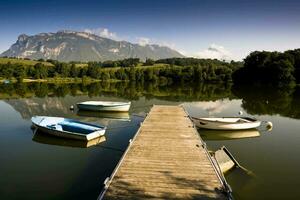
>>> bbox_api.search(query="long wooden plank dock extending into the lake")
[99,106,229,199]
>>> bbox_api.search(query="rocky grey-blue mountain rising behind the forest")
[0,31,184,61]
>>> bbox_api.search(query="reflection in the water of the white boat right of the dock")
[199,129,260,140]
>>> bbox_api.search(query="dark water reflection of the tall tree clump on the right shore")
[232,86,300,118]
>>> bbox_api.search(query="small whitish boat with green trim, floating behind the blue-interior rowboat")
[77,101,131,112]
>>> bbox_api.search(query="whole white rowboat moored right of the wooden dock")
[192,117,261,130]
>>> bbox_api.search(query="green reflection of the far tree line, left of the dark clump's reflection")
[0,81,233,101]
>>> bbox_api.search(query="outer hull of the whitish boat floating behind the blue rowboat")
[77,103,130,112]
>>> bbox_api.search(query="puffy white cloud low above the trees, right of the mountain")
[193,44,232,60]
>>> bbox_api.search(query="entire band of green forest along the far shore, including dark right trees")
[0,49,300,86]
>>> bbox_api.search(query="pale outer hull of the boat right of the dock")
[192,118,261,130]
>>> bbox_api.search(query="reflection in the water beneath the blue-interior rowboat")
[32,132,105,148]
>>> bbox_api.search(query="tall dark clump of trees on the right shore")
[232,49,300,85]
